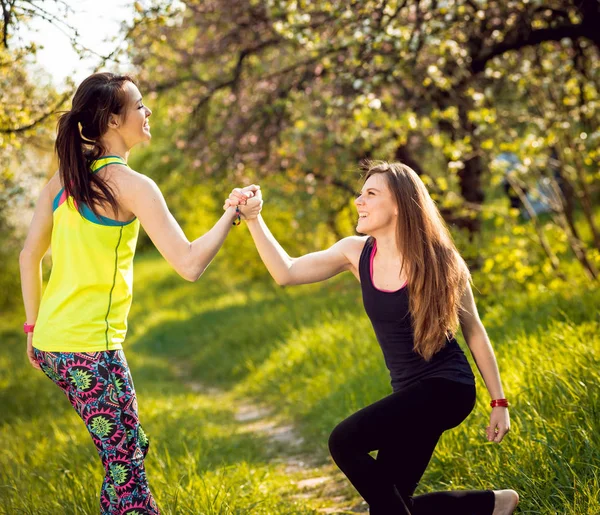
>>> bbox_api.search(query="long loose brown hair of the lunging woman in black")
[361,161,470,361]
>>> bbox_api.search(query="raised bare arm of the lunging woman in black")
[248,215,362,285]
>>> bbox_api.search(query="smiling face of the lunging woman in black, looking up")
[354,173,398,236]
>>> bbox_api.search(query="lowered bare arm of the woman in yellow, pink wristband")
[19,176,58,368]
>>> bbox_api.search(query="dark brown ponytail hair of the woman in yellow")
[55,73,134,216]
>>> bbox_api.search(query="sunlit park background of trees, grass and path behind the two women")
[0,0,600,515]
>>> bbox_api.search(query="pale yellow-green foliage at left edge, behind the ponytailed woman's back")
[0,0,71,310]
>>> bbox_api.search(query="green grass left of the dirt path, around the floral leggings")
[0,314,328,515]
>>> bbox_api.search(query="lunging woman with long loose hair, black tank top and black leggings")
[224,162,519,515]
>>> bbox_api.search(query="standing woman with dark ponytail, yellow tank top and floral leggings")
[20,73,262,515]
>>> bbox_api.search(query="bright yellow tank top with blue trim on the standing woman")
[33,156,140,352]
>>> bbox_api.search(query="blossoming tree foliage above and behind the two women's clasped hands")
[122,0,600,286]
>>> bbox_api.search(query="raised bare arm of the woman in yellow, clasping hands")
[119,172,261,281]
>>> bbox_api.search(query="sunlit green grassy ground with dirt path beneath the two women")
[0,239,600,515]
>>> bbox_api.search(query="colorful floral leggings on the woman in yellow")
[34,349,159,515]
